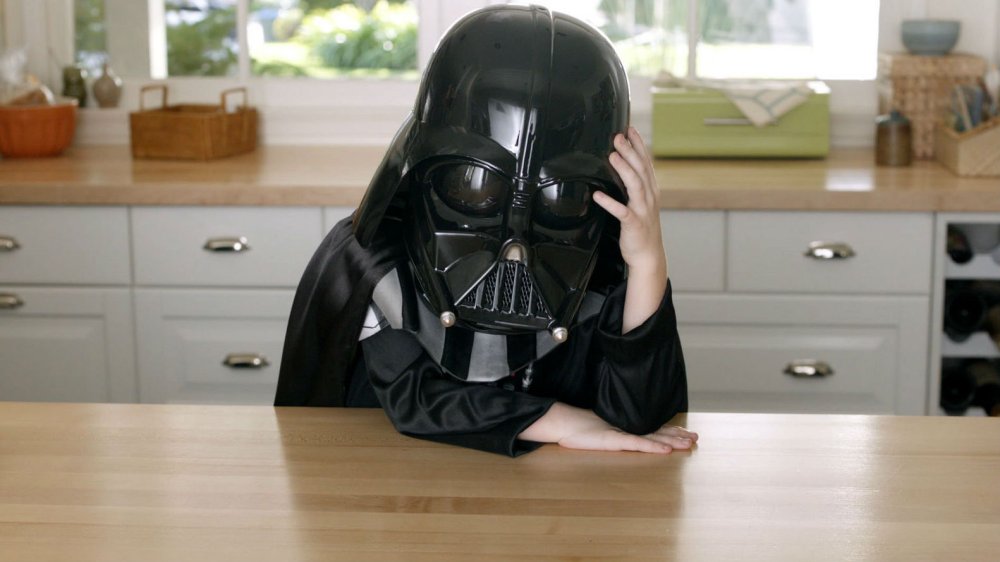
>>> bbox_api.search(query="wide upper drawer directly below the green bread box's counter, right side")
[728,212,933,294]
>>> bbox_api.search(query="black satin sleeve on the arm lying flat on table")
[361,329,555,456]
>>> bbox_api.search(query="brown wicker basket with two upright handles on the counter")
[129,84,257,160]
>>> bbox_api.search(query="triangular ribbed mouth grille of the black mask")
[458,260,549,319]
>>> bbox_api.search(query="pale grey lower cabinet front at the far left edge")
[0,286,136,402]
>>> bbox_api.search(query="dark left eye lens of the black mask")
[427,164,510,217]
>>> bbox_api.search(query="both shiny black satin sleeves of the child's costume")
[349,276,688,456]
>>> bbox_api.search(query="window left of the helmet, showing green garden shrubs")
[74,0,417,79]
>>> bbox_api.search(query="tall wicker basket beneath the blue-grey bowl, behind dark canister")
[878,53,986,158]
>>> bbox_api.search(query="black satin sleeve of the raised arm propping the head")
[588,281,688,434]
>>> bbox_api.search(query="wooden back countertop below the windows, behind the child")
[0,146,1000,211]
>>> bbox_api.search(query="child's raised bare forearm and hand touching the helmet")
[594,127,667,334]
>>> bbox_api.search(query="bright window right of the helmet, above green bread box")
[528,0,878,80]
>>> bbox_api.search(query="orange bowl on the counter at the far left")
[0,98,77,158]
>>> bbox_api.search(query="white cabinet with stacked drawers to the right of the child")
[665,212,934,414]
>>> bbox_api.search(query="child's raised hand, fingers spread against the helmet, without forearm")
[594,127,666,271]
